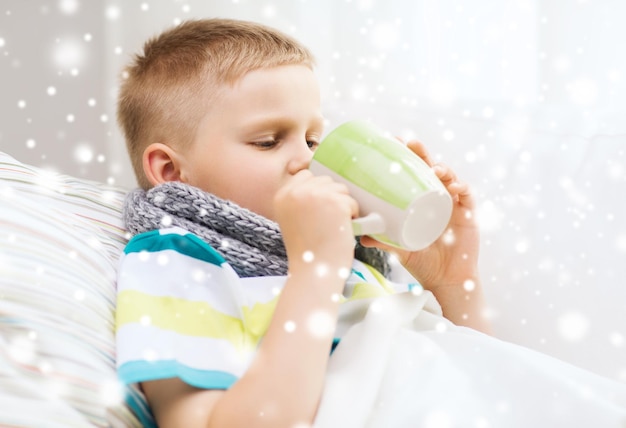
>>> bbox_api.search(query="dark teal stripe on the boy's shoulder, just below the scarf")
[124,230,226,266]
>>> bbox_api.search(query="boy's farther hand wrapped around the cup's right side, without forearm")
[361,141,479,292]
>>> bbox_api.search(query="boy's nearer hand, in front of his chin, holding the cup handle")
[274,170,358,280]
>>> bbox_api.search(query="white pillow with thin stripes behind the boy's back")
[0,152,145,427]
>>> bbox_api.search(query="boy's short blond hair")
[117,19,314,189]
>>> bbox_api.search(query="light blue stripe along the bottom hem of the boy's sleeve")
[117,360,237,389]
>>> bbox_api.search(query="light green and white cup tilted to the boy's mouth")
[309,121,452,251]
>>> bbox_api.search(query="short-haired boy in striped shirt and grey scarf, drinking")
[117,19,487,427]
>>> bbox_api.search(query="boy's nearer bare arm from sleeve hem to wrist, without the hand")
[142,270,343,427]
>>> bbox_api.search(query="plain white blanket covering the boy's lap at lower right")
[314,292,626,428]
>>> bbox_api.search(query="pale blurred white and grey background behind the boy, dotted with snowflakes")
[0,0,626,381]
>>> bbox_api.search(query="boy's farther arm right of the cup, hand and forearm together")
[361,141,491,333]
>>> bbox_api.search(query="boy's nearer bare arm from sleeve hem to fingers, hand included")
[142,170,357,427]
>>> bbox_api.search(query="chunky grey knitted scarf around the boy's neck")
[124,182,390,277]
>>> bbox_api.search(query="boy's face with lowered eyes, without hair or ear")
[181,65,323,224]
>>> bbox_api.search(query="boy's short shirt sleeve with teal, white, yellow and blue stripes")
[116,228,256,389]
